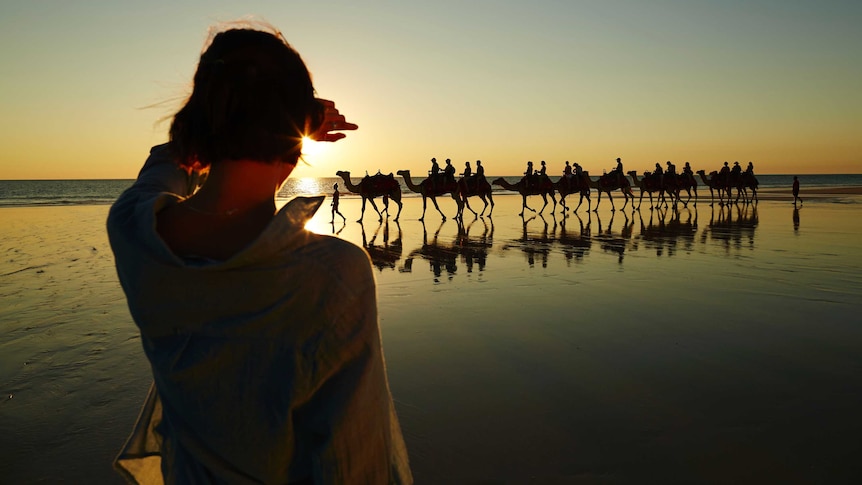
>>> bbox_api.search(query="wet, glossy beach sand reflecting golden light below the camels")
[0,187,862,484]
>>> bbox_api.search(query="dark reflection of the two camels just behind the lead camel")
[399,217,494,282]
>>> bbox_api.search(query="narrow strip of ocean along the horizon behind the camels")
[0,174,862,207]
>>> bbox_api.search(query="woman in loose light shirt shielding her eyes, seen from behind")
[107,24,412,484]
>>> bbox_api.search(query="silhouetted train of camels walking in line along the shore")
[336,162,758,218]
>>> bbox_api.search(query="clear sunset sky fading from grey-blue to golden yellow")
[0,0,862,179]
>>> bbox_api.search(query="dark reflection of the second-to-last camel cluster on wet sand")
[637,205,697,256]
